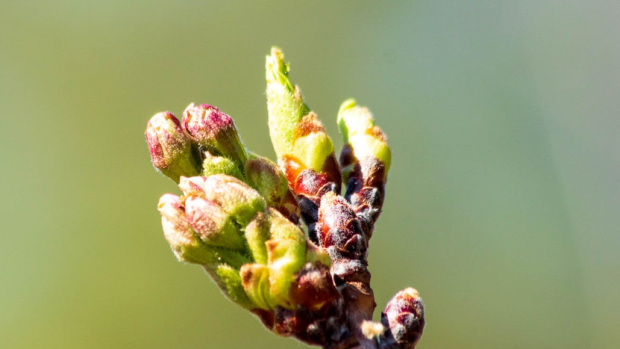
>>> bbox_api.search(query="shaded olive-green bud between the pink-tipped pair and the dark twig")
[245,153,299,223]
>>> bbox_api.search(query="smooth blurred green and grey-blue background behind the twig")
[0,0,620,349]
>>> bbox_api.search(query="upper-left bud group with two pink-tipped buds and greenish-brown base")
[145,103,300,223]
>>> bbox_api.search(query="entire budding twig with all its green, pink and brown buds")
[145,48,425,349]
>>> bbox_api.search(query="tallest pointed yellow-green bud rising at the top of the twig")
[266,47,334,173]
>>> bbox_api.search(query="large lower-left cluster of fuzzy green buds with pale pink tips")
[159,174,337,312]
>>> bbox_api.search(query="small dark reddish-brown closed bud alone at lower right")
[381,287,425,349]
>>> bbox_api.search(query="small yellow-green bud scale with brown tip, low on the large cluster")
[240,264,274,310]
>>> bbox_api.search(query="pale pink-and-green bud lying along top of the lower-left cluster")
[179,174,265,227]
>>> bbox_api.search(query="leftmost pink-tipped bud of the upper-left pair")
[144,112,200,183]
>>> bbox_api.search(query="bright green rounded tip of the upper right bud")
[338,99,392,174]
